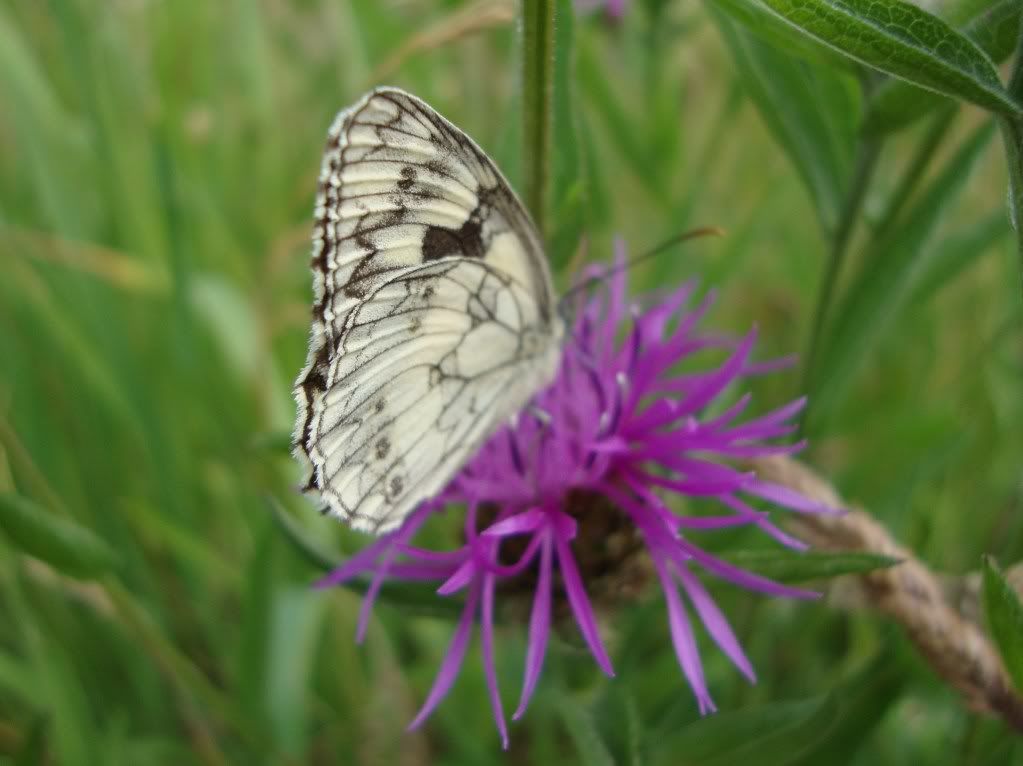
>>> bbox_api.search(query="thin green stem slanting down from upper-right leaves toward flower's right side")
[802,138,881,413]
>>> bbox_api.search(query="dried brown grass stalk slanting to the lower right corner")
[753,457,1023,731]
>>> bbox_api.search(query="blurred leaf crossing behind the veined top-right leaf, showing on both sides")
[863,0,1023,134]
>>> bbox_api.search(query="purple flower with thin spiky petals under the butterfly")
[321,239,834,747]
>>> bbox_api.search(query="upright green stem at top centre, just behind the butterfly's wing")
[522,0,558,240]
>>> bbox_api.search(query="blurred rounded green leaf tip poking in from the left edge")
[0,493,118,579]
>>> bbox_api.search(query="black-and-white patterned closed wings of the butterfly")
[295,88,563,533]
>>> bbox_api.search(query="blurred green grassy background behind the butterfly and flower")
[0,0,1023,764]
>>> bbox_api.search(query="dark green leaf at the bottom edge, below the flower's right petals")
[652,695,838,766]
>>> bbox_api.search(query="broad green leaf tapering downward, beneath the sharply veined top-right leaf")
[711,7,858,231]
